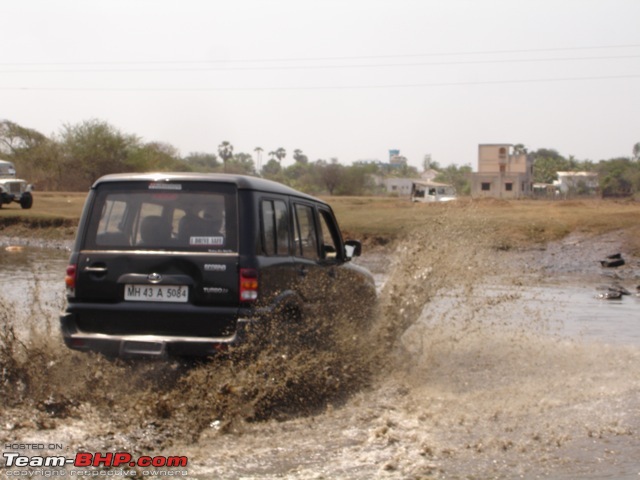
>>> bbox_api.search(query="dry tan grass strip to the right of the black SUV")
[327,197,640,254]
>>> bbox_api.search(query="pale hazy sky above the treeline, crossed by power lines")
[0,0,640,169]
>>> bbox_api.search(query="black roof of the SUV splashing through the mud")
[91,172,326,204]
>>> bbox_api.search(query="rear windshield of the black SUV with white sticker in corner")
[84,182,238,252]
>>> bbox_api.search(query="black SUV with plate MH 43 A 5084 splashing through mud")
[60,173,376,356]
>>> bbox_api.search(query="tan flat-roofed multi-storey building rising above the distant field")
[471,143,533,198]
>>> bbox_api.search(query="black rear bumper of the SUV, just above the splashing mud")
[60,311,256,357]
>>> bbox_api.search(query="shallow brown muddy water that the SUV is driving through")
[0,232,640,479]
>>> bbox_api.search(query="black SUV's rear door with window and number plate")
[75,181,238,308]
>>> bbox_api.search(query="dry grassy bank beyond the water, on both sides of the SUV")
[0,192,640,255]
